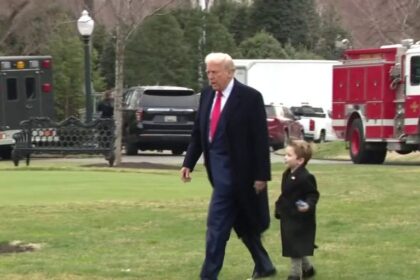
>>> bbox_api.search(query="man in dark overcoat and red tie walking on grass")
[181,53,276,280]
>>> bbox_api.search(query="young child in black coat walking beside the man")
[275,140,319,280]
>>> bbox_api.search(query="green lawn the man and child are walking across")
[0,159,420,280]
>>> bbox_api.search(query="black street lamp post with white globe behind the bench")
[77,10,95,123]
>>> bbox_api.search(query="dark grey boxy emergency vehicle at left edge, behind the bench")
[0,56,54,159]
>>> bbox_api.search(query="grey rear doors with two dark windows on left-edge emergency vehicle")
[0,71,41,128]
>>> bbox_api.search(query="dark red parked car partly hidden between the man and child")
[265,105,303,150]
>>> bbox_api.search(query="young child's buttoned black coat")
[276,166,319,258]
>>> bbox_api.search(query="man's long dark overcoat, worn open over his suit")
[183,80,271,235]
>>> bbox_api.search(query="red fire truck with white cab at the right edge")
[332,39,420,164]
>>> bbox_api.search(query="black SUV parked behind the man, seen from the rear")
[123,86,199,155]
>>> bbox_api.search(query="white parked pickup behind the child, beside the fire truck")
[290,105,337,142]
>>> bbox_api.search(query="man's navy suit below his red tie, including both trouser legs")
[200,143,274,280]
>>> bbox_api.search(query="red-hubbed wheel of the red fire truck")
[349,119,371,164]
